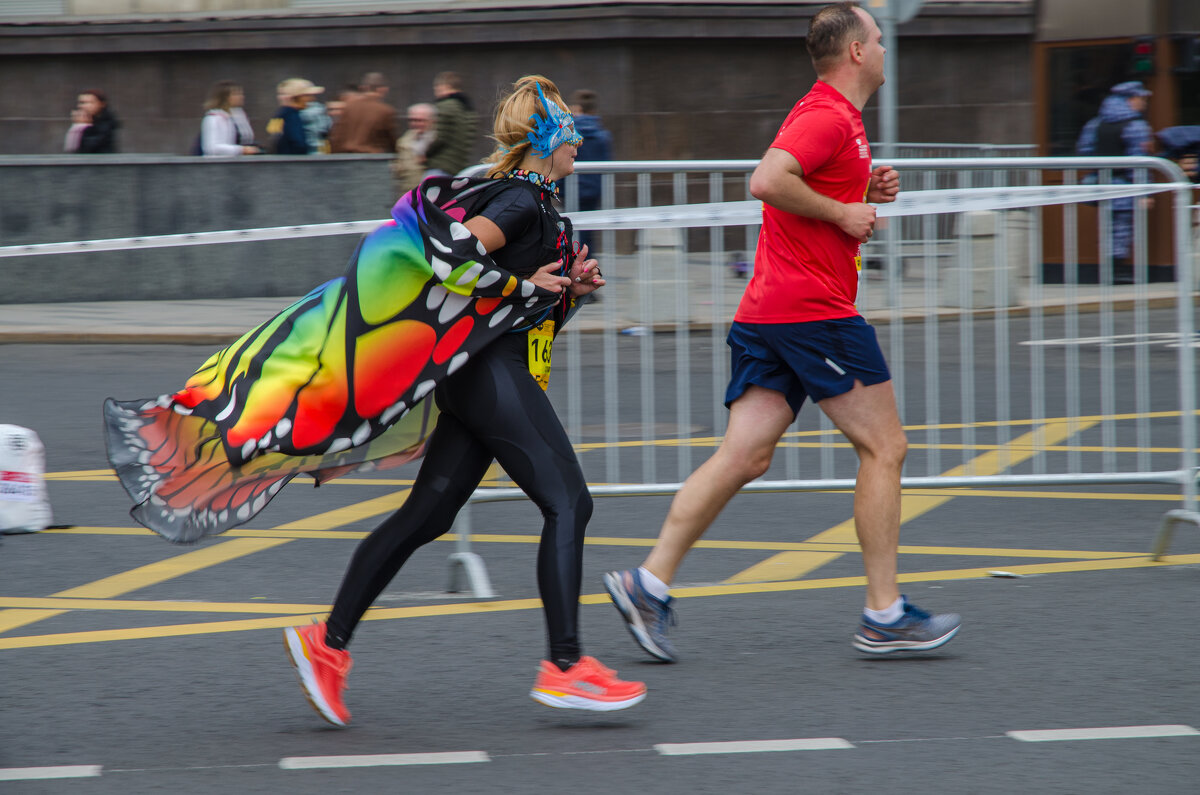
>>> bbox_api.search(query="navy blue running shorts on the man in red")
[725,316,892,414]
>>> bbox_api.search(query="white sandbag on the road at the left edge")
[0,425,53,533]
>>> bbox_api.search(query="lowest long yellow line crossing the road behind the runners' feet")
[0,555,1200,650]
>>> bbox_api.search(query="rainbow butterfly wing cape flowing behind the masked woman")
[104,178,558,543]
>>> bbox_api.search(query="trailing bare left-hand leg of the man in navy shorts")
[642,385,801,585]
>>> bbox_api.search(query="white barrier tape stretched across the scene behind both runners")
[0,183,1192,258]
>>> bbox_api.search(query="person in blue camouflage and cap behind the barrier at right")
[1075,80,1154,267]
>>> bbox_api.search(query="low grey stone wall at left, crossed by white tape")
[0,155,395,304]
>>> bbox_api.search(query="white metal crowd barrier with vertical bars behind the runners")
[452,157,1200,598]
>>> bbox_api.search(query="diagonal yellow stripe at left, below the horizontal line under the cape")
[0,538,292,634]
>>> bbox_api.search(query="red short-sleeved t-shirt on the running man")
[734,80,871,323]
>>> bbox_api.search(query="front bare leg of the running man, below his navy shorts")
[817,381,908,610]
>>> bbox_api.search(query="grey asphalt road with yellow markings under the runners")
[0,329,1200,794]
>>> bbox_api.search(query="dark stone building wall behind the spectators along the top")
[0,2,1034,160]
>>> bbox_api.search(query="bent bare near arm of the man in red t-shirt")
[750,148,875,243]
